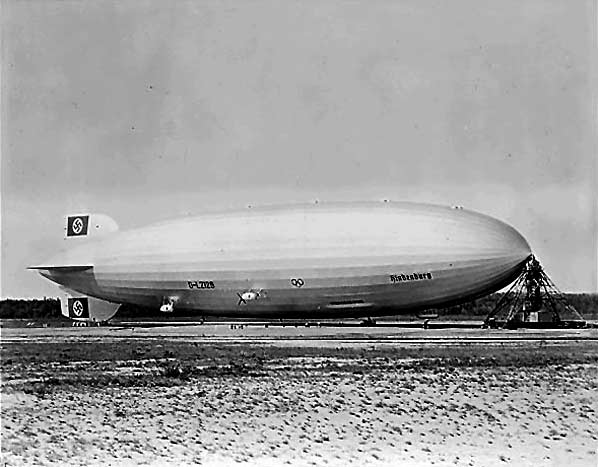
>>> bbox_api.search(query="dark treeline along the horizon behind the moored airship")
[0,294,598,319]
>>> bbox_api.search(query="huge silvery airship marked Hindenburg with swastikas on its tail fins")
[31,201,531,321]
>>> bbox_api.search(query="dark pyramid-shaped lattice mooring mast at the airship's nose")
[484,256,586,328]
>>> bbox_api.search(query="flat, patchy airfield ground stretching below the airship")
[1,325,598,466]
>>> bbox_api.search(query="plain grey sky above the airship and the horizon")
[1,0,597,297]
